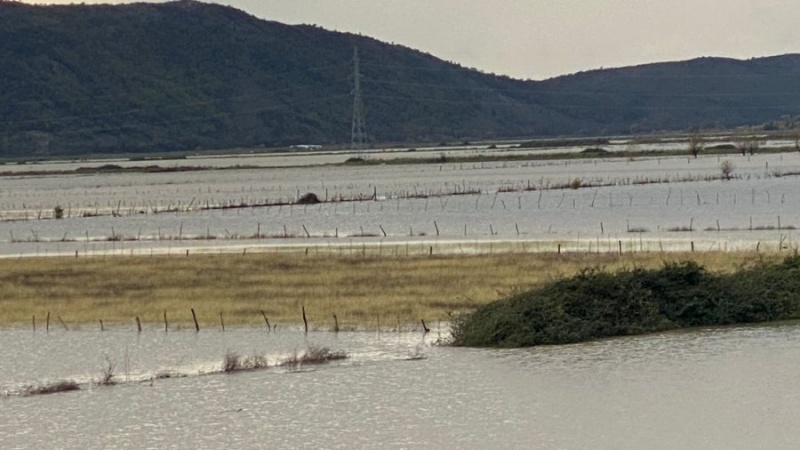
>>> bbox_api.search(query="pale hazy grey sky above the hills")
[20,0,800,79]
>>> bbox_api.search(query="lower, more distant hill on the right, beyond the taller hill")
[537,55,800,133]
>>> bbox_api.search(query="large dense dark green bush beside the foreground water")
[452,255,800,347]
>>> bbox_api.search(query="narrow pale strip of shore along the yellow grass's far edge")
[0,232,798,260]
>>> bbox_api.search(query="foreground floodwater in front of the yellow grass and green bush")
[0,324,800,450]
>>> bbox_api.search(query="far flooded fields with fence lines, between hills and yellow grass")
[0,153,800,256]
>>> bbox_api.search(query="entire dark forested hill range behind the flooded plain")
[0,0,800,156]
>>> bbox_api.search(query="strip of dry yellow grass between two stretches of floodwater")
[0,252,779,329]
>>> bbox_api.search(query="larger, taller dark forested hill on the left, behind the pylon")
[0,1,572,154]
